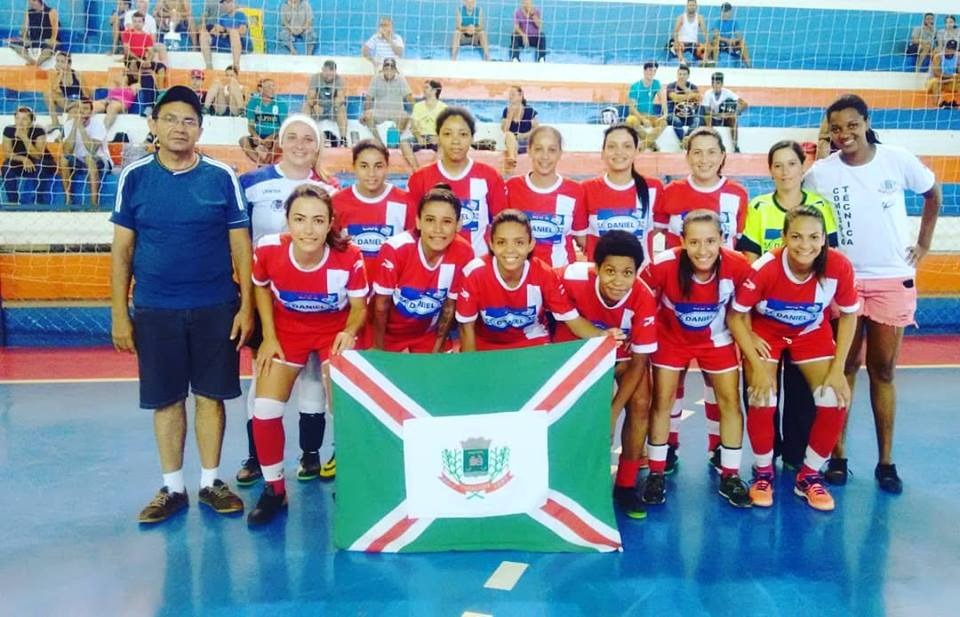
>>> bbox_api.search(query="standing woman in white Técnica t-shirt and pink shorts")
[804,94,941,493]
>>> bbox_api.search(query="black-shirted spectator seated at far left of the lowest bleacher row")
[3,106,57,204]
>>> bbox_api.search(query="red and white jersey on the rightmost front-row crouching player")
[733,247,860,338]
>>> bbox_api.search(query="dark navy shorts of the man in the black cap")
[133,302,240,409]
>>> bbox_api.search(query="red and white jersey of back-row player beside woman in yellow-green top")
[653,177,750,249]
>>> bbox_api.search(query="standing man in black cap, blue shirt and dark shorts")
[110,86,253,523]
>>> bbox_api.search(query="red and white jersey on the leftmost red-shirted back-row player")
[333,183,416,281]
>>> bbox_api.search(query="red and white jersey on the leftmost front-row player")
[253,233,368,337]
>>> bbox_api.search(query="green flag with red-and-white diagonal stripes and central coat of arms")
[331,338,620,552]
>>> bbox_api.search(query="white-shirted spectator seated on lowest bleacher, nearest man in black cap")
[61,100,113,208]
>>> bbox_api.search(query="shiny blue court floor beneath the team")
[0,369,960,617]
